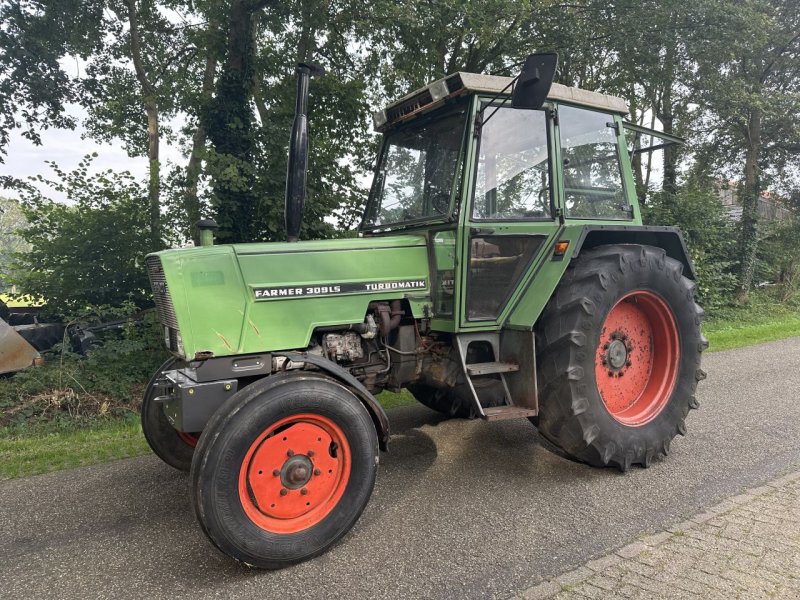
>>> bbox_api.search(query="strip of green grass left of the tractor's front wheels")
[0,418,150,480]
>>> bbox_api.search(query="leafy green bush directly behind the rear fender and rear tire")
[642,182,737,314]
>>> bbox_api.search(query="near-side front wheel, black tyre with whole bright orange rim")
[191,373,378,569]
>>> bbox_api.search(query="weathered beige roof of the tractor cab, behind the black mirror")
[373,72,628,132]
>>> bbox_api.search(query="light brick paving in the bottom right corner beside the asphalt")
[515,471,800,600]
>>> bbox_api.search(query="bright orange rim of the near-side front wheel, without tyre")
[239,413,351,533]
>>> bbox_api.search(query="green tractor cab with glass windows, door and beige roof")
[361,65,641,331]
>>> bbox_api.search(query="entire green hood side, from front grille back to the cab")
[158,235,431,359]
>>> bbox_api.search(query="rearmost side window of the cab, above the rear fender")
[558,106,632,219]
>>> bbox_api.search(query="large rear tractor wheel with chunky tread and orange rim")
[534,245,708,471]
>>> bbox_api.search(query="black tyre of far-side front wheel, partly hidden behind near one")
[142,358,200,471]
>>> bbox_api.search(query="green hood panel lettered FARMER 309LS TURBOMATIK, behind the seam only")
[237,236,431,352]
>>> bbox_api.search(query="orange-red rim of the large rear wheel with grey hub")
[595,290,680,427]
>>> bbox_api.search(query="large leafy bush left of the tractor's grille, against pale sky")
[9,156,158,314]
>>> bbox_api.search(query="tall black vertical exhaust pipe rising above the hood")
[284,63,325,242]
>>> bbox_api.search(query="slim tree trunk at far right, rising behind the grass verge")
[738,107,762,304]
